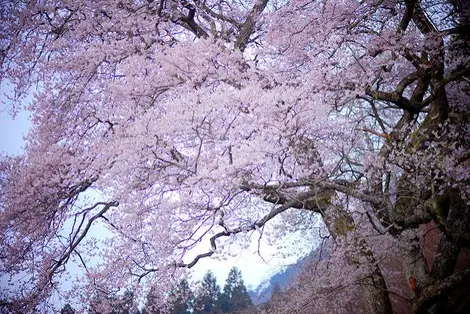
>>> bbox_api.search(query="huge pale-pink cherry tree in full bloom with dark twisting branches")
[0,0,470,313]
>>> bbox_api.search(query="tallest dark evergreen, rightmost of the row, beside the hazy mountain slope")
[219,267,252,313]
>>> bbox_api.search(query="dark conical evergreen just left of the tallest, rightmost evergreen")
[193,271,221,314]
